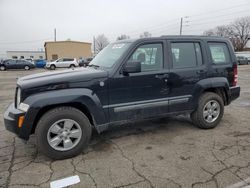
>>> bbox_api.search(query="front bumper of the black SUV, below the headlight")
[4,103,26,139]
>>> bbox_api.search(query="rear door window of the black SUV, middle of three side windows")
[171,42,203,69]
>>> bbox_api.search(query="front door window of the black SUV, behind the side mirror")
[129,43,163,72]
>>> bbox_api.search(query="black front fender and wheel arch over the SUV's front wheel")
[22,89,107,139]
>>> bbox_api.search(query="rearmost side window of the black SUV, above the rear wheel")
[208,42,230,64]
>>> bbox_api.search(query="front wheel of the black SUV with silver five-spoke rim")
[35,106,92,159]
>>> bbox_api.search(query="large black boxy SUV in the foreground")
[4,36,240,159]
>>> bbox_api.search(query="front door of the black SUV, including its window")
[109,41,169,122]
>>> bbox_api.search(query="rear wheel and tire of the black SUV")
[191,92,224,129]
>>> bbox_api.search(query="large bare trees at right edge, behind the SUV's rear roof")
[203,17,250,51]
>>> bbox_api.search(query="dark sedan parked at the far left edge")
[0,59,35,71]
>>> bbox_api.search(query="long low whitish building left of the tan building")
[6,51,45,59]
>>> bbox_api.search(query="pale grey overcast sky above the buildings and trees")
[0,0,250,56]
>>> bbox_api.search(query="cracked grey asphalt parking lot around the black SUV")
[0,66,250,188]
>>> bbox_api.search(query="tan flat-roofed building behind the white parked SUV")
[44,41,92,61]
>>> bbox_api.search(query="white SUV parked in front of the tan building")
[46,58,79,70]
